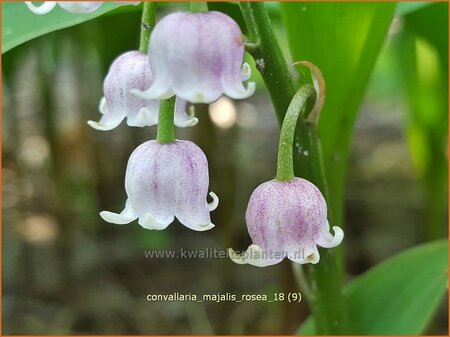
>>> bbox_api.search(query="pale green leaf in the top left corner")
[1,2,136,54]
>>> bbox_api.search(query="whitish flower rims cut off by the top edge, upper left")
[25,1,140,15]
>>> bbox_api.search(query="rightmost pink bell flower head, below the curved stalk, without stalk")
[229,178,344,267]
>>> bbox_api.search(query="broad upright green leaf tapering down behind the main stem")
[281,2,395,225]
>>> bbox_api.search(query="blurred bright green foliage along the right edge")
[395,3,448,240]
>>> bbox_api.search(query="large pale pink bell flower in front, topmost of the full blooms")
[133,12,255,103]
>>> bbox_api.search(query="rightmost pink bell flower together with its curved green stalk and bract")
[229,62,344,267]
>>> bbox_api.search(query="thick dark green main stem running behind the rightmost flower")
[240,2,348,335]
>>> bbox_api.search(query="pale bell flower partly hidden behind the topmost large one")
[88,51,198,131]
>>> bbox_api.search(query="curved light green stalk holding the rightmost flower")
[275,84,316,181]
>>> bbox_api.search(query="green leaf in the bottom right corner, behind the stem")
[298,241,448,335]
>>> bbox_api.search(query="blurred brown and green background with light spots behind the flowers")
[2,3,448,335]
